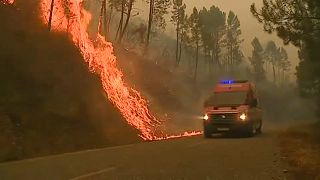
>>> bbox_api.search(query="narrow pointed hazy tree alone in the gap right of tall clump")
[249,37,266,82]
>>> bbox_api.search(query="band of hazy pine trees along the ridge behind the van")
[87,0,296,85]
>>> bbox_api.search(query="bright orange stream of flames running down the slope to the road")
[35,0,201,140]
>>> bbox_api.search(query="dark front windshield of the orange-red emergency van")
[205,91,247,107]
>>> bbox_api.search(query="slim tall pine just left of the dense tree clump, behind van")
[189,7,201,80]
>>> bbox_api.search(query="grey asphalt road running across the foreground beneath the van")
[0,131,291,180]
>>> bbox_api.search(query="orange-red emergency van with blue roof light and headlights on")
[203,80,262,138]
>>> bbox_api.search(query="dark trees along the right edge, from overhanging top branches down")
[251,0,320,117]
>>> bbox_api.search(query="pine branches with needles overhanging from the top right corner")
[251,0,320,46]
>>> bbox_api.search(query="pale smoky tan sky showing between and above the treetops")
[135,0,299,78]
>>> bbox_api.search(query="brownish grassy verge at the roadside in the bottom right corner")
[280,123,320,180]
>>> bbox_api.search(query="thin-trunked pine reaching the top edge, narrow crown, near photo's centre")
[171,0,186,64]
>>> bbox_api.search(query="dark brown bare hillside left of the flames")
[0,0,139,162]
